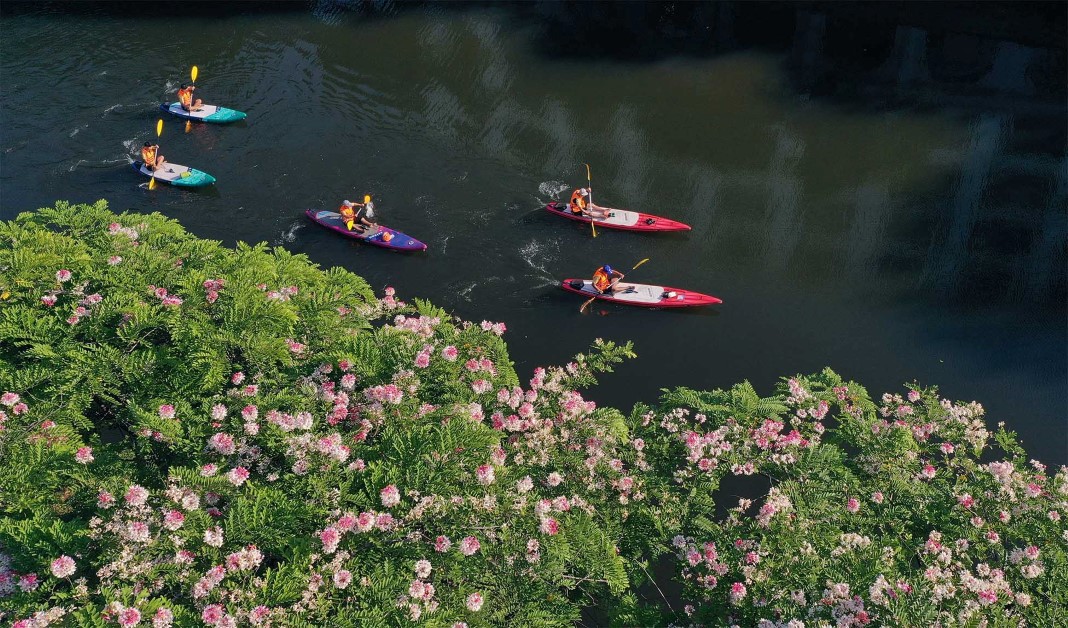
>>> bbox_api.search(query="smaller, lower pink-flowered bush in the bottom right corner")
[635,371,1068,627]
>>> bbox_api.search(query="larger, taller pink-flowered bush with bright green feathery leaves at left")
[0,203,631,627]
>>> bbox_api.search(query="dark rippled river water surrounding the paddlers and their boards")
[0,2,1068,462]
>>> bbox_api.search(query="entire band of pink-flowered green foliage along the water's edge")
[0,202,1068,628]
